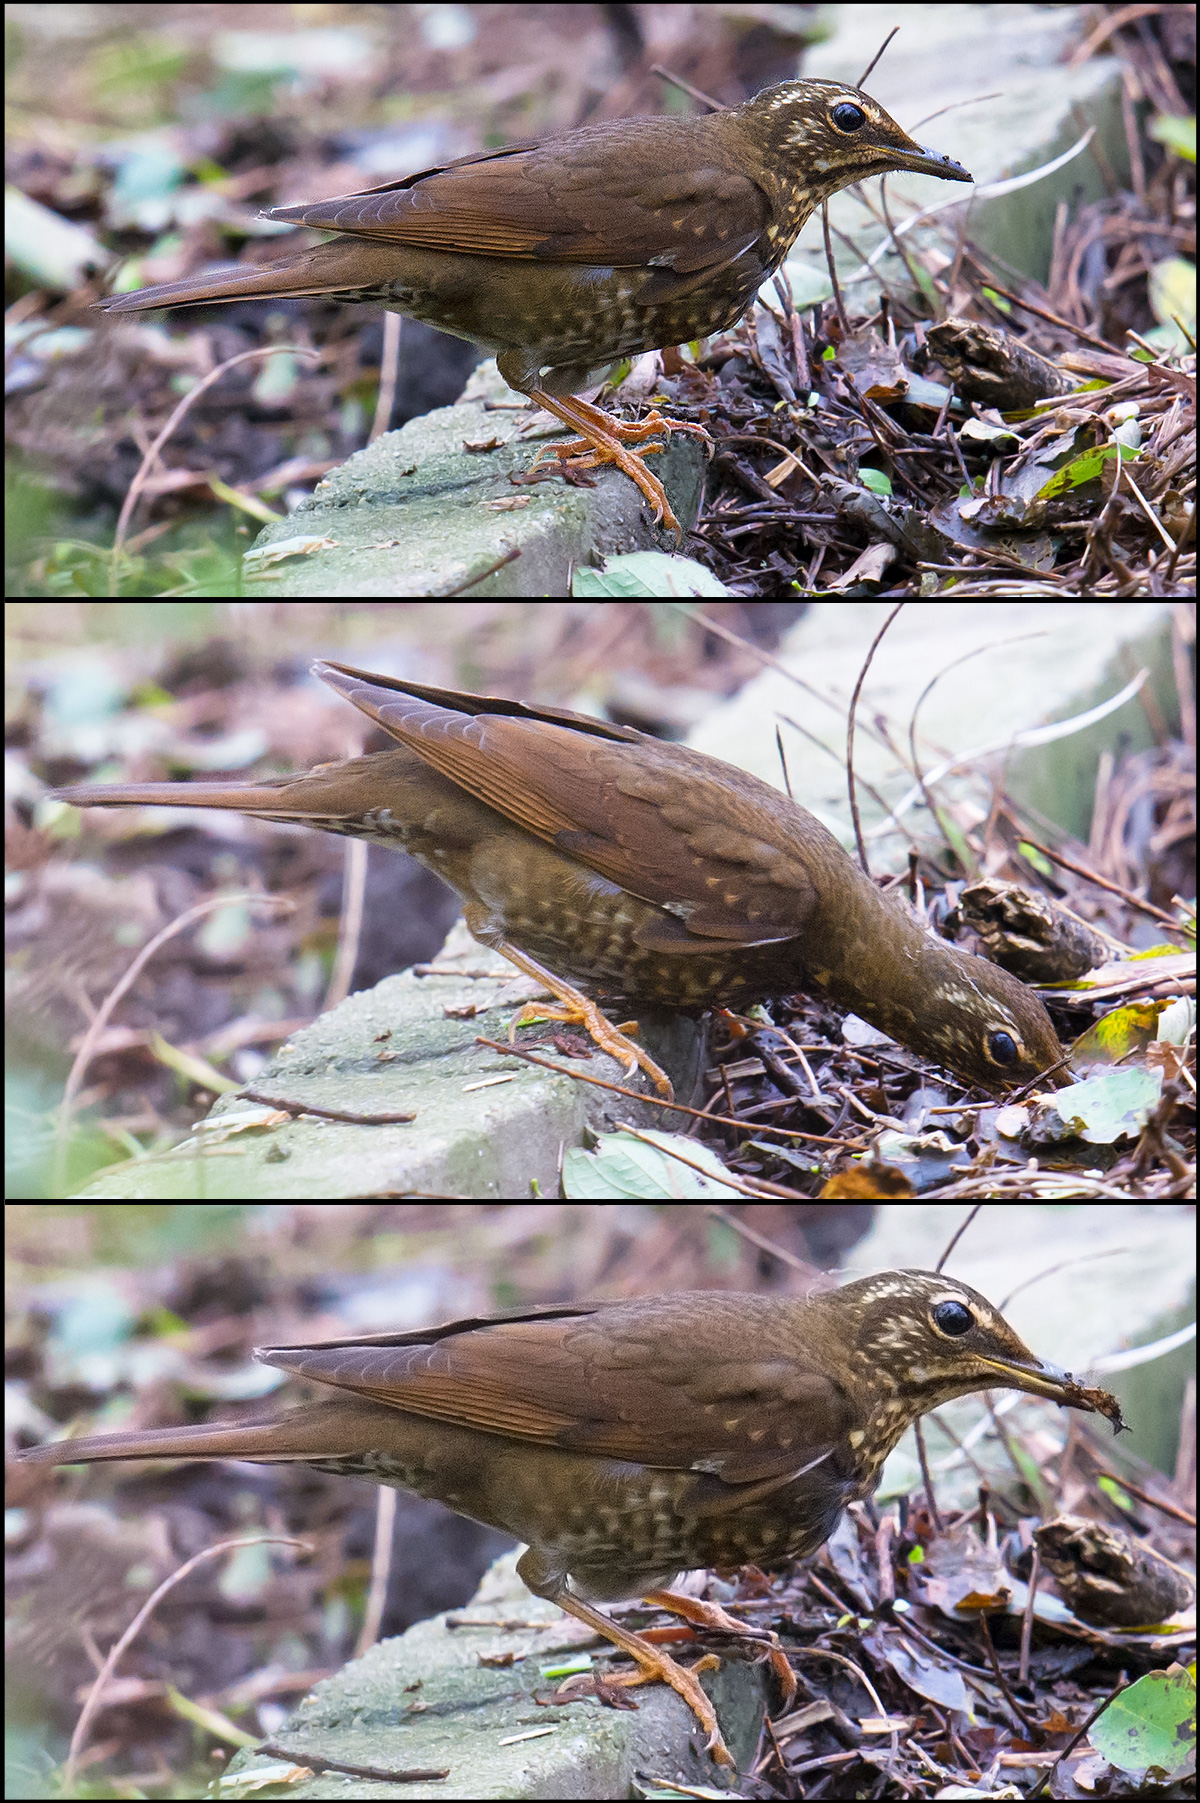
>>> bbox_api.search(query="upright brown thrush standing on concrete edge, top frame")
[99,81,971,532]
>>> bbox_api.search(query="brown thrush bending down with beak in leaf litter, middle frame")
[56,664,1061,1093]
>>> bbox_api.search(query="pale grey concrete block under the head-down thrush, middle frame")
[67,927,705,1201]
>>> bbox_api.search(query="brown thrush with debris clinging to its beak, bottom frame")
[18,1271,1123,1763]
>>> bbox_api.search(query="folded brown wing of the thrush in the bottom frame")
[258,1291,849,1484]
